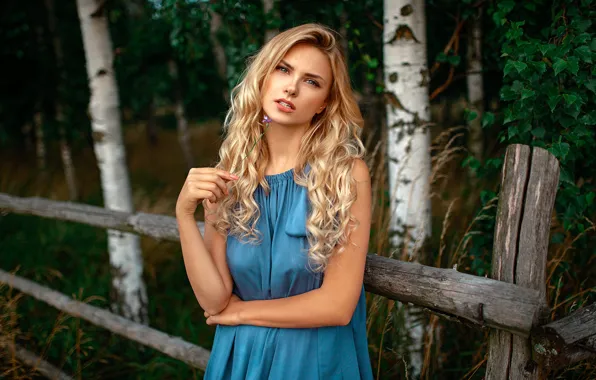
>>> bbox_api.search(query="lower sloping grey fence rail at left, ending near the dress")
[0,269,210,370]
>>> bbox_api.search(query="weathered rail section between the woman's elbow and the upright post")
[364,255,540,337]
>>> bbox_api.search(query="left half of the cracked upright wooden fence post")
[486,145,530,380]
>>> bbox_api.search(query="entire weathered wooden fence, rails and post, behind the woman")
[0,145,596,380]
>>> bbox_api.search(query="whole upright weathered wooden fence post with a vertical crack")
[486,145,559,380]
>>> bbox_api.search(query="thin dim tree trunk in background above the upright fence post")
[467,8,484,166]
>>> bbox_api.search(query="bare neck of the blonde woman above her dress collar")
[264,122,308,174]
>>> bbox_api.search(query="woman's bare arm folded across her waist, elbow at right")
[207,160,372,328]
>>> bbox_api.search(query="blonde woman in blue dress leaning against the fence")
[176,24,372,380]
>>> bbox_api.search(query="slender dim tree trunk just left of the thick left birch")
[45,0,79,201]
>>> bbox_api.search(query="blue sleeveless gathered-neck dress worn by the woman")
[204,167,373,380]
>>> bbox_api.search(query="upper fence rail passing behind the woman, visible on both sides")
[0,193,543,337]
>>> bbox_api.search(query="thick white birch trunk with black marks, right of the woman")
[383,0,431,378]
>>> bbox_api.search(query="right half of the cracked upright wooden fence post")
[510,147,559,380]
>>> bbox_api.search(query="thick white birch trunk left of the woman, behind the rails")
[77,0,147,323]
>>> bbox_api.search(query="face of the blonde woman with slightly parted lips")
[262,44,333,126]
